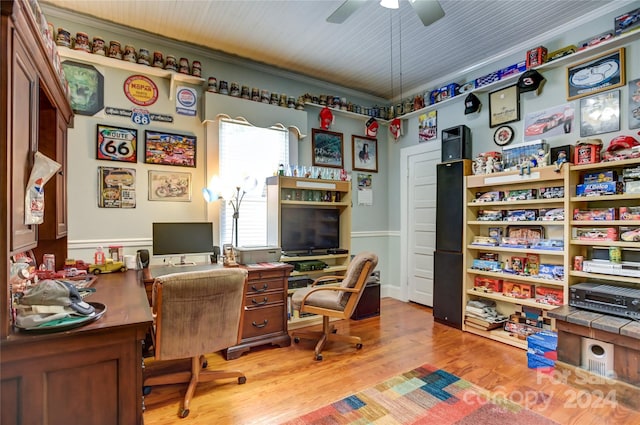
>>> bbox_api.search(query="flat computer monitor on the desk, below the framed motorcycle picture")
[153,222,213,264]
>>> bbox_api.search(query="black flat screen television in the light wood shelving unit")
[280,205,340,255]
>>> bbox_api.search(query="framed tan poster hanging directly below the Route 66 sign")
[98,167,136,208]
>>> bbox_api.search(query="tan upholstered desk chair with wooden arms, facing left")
[291,252,378,360]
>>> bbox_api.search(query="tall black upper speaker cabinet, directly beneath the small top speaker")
[436,160,471,252]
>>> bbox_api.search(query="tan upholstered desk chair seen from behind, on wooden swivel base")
[144,268,247,418]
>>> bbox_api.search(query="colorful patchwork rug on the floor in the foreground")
[283,365,558,425]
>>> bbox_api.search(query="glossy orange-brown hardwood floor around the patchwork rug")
[144,298,640,425]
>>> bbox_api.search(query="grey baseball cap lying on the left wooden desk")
[20,279,95,316]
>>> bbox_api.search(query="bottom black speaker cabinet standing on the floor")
[433,251,463,329]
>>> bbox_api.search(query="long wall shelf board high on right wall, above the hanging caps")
[399,31,640,119]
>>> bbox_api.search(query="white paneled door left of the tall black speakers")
[402,141,440,306]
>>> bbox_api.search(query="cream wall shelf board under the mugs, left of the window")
[58,46,205,100]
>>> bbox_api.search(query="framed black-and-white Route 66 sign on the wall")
[96,124,138,163]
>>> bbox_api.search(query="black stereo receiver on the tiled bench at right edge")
[569,282,640,320]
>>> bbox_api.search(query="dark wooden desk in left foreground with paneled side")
[0,271,152,425]
